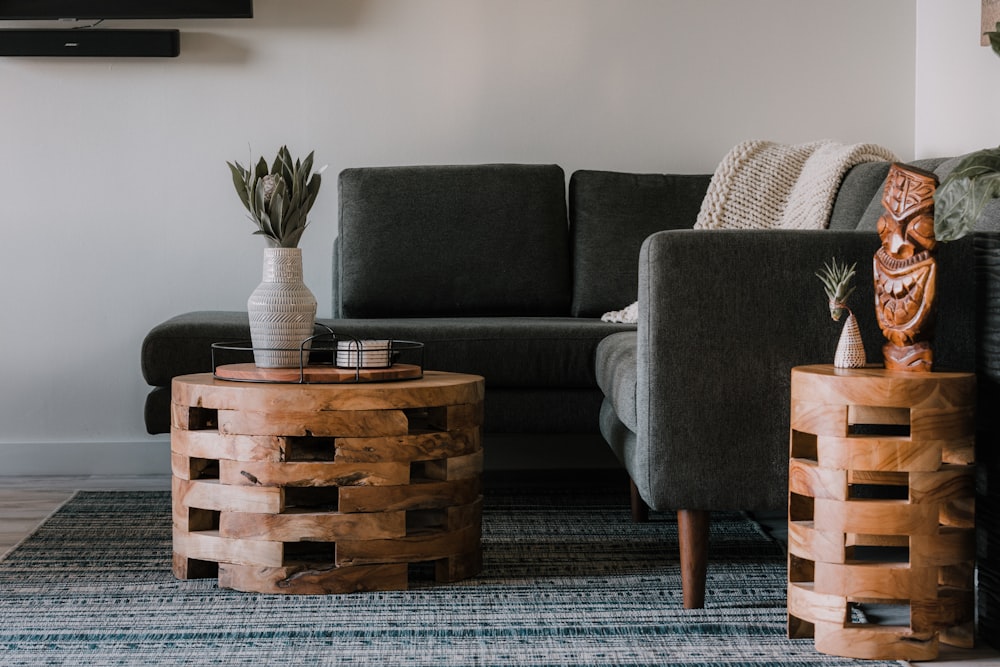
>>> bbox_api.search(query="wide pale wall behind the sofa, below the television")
[0,0,920,474]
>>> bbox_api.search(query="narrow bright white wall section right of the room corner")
[914,0,1000,157]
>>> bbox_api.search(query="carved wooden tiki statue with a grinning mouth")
[875,164,937,372]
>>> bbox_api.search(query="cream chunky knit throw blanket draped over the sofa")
[695,141,899,229]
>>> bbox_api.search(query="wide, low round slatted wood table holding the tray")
[170,371,484,594]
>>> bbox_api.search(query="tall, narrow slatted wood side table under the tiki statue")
[788,365,976,660]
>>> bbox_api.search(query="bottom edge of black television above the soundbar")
[0,0,253,21]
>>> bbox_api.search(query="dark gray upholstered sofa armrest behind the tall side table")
[632,230,975,509]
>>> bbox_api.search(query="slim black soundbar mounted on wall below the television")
[0,28,181,58]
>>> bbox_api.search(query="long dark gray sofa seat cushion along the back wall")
[142,311,635,389]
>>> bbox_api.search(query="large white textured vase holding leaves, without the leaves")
[247,248,316,368]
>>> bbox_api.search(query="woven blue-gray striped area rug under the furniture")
[0,489,900,667]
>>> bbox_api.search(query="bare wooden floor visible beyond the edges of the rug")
[0,476,1000,667]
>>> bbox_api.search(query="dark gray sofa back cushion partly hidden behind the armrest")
[569,170,711,317]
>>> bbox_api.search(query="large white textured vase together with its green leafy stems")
[226,146,325,368]
